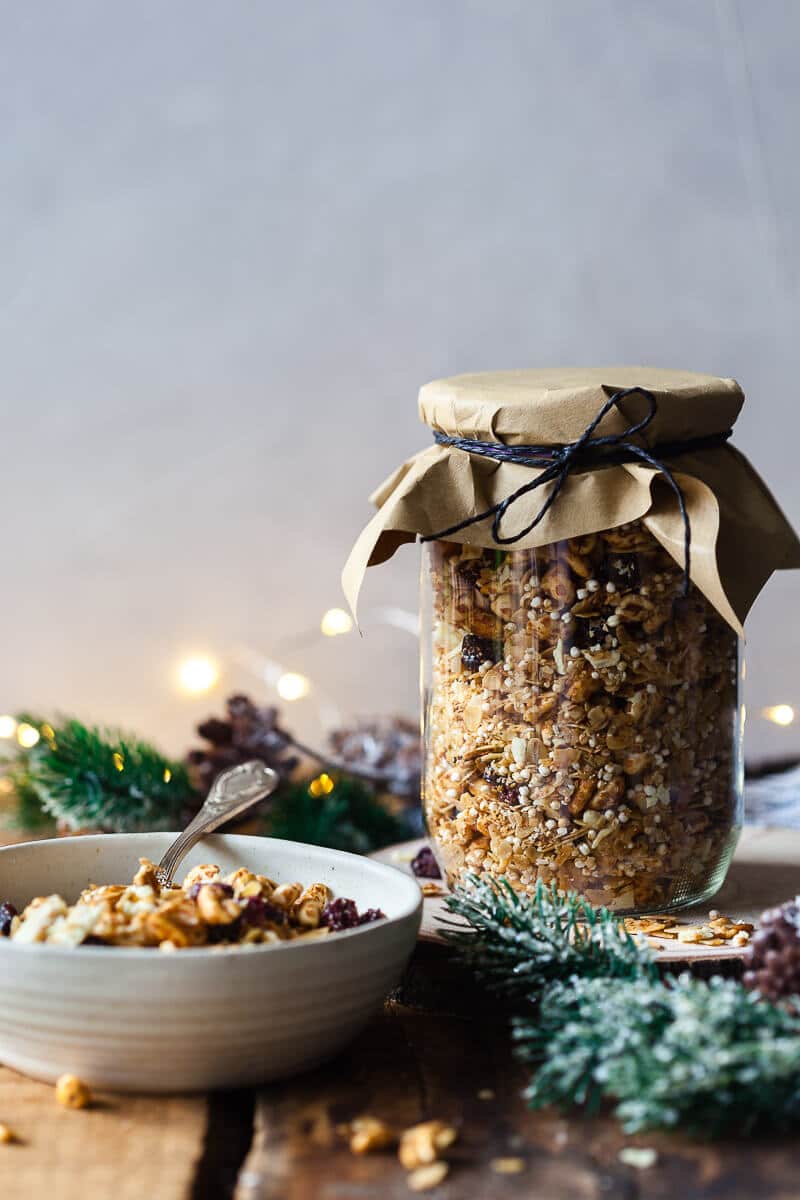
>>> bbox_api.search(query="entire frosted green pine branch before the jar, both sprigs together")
[446,878,800,1136]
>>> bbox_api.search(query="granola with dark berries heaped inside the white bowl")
[0,858,384,952]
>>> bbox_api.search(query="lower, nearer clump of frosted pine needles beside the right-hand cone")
[513,976,800,1136]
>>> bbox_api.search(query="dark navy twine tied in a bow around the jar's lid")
[422,388,733,595]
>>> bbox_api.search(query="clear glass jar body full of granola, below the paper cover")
[423,522,744,913]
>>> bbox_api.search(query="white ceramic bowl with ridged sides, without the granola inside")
[0,833,422,1092]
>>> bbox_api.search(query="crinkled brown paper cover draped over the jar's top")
[342,367,800,632]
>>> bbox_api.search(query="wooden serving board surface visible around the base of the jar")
[372,826,800,966]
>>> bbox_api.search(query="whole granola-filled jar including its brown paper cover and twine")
[345,368,800,913]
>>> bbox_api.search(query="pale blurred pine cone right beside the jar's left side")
[330,716,422,799]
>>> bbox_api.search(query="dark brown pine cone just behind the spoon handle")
[186,696,297,796]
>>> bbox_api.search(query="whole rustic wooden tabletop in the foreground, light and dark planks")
[0,830,800,1200]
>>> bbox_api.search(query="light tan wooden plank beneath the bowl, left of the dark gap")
[0,1067,206,1200]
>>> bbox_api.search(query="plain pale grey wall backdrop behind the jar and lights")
[0,0,800,755]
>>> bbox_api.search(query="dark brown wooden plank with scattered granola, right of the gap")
[236,1007,798,1200]
